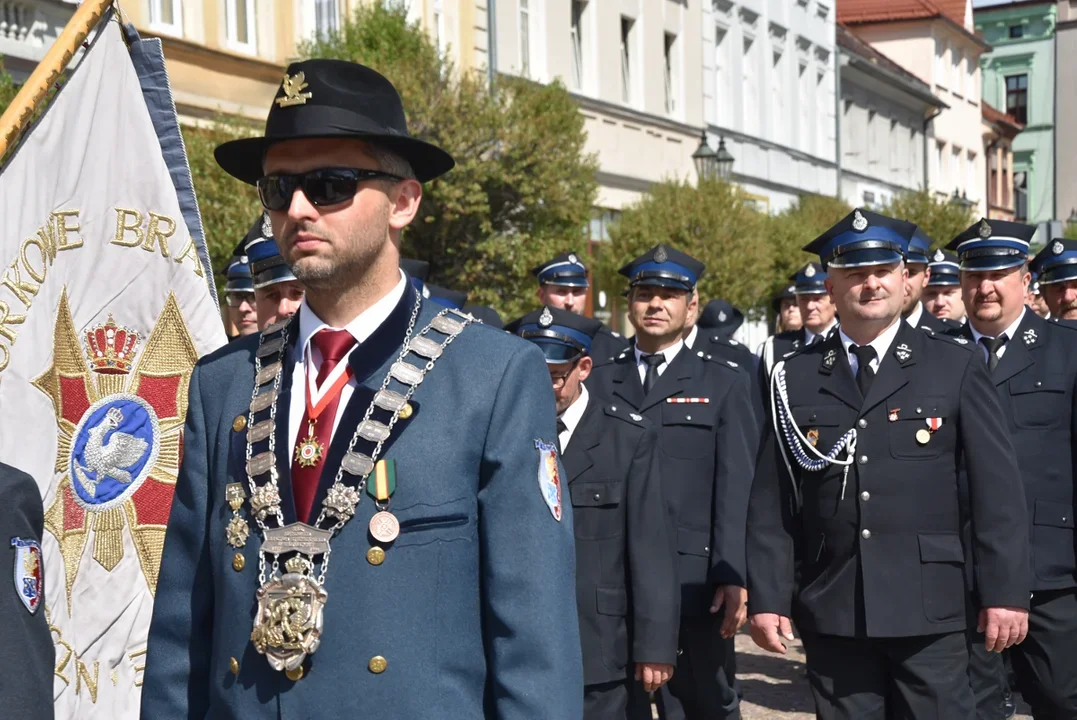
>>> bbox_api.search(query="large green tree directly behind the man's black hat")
[300,0,598,317]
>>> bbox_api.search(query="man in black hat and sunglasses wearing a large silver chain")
[142,59,583,720]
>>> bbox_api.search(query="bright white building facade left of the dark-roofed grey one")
[697,0,838,212]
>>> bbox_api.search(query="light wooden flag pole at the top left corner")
[0,0,112,158]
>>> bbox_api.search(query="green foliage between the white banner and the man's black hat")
[180,115,262,291]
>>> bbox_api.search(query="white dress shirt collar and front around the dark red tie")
[288,272,407,456]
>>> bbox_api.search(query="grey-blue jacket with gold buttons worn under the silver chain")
[142,285,583,720]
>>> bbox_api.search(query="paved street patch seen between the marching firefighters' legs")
[737,632,1032,720]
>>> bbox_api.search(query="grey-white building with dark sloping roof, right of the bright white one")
[837,25,947,208]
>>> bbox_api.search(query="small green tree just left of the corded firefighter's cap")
[763,190,853,299]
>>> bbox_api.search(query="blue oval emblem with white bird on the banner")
[69,394,160,511]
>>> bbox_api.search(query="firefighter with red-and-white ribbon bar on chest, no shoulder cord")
[588,245,757,720]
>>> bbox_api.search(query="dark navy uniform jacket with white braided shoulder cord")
[747,321,1030,637]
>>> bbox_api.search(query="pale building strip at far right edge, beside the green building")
[1054,0,1077,223]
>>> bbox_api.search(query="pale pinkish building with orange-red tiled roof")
[838,0,990,215]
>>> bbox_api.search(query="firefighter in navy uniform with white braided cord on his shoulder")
[747,209,1029,720]
